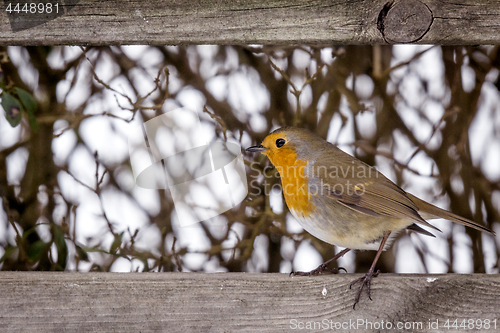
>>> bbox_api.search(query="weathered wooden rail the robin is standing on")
[0,272,500,332]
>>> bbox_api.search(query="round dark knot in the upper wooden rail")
[377,0,433,43]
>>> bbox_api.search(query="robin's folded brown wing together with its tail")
[307,142,494,234]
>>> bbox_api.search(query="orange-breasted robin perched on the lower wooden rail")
[247,127,494,307]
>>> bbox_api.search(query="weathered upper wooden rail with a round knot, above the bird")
[0,0,500,45]
